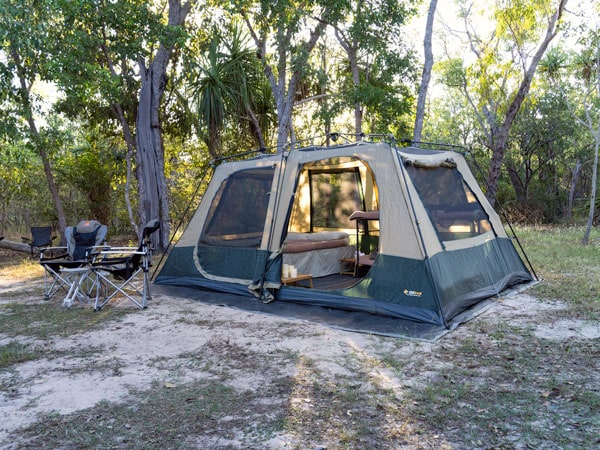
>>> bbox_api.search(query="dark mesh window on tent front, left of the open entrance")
[200,168,275,248]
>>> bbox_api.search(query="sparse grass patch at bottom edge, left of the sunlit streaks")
[20,380,290,449]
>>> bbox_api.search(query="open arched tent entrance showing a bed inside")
[283,156,379,290]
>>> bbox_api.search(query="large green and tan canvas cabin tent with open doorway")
[155,140,533,326]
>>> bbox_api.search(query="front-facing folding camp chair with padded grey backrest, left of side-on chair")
[40,220,108,304]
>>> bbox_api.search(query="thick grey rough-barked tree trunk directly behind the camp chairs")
[136,0,190,251]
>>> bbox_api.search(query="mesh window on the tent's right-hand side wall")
[406,166,492,241]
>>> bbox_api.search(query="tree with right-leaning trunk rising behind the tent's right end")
[440,0,567,204]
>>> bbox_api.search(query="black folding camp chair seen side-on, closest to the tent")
[90,220,160,311]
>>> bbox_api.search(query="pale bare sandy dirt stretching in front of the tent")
[0,272,600,448]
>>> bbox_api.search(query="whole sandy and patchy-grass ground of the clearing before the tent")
[0,230,600,449]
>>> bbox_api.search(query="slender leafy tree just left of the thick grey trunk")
[50,0,164,235]
